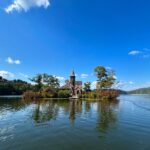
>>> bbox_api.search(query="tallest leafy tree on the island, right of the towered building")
[94,66,116,90]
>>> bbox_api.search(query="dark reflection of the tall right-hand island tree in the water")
[97,100,118,133]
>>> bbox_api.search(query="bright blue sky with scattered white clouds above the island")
[0,0,150,90]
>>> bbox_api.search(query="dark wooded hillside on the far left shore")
[0,76,32,95]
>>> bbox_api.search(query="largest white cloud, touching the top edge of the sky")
[5,0,50,13]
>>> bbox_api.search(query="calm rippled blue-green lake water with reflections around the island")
[0,95,150,150]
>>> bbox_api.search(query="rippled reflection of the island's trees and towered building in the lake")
[26,100,119,133]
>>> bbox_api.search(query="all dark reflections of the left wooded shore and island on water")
[0,99,119,133]
